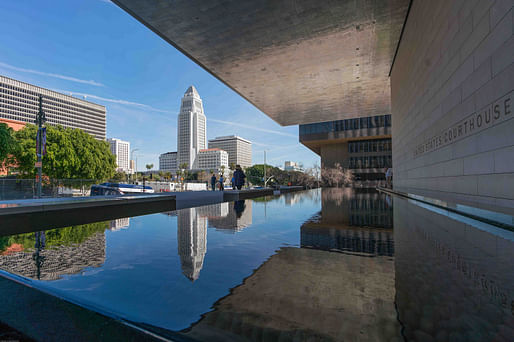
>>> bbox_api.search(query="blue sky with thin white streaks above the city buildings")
[0,0,319,170]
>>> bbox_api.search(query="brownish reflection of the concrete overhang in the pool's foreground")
[188,248,399,341]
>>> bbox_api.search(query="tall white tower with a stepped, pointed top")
[177,86,207,169]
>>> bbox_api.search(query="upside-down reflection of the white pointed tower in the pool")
[177,208,207,281]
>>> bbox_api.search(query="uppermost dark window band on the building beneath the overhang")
[299,114,391,135]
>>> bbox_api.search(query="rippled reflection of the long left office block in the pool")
[0,233,105,280]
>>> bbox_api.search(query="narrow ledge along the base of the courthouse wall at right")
[377,187,514,231]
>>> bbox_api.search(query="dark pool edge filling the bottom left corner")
[0,272,198,342]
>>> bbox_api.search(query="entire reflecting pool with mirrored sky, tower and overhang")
[0,188,514,341]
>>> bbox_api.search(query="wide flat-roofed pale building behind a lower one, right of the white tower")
[209,135,252,167]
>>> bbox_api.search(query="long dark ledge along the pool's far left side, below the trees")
[0,186,303,236]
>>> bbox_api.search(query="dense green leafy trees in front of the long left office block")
[13,124,116,180]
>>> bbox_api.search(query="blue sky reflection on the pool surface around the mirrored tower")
[22,192,320,330]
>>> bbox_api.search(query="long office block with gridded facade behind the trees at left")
[0,75,106,140]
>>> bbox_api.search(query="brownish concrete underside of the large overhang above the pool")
[113,0,410,125]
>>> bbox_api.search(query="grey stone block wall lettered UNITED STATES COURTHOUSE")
[391,0,514,207]
